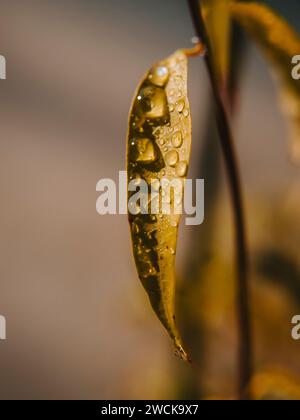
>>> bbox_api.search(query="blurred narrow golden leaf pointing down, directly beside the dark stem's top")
[201,0,231,84]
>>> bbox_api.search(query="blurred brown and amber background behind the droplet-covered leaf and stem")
[0,0,300,399]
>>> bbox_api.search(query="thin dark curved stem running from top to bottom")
[188,0,252,399]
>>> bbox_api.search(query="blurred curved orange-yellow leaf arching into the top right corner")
[231,3,300,160]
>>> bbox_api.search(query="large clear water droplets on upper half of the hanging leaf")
[131,59,189,177]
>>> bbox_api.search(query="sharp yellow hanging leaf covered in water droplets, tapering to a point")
[127,50,191,360]
